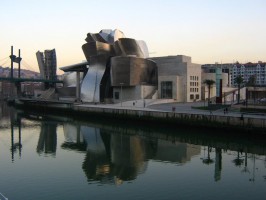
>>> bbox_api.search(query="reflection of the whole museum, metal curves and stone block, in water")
[62,124,200,184]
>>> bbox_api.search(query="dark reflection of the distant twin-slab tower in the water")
[37,121,57,155]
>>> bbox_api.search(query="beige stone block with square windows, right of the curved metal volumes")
[150,55,201,102]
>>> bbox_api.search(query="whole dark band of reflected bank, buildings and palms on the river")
[6,107,266,185]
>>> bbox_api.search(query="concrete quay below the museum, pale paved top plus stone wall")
[70,100,266,134]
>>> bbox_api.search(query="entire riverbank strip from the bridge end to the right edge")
[11,99,266,134]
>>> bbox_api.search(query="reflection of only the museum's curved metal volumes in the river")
[62,124,156,184]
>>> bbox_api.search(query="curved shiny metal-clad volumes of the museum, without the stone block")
[81,29,157,102]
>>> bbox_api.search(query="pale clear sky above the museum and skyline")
[0,0,266,73]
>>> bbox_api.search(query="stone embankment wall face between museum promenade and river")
[73,106,266,134]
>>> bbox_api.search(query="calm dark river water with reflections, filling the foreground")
[0,106,266,200]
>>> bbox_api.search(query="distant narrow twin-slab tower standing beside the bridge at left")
[36,49,57,80]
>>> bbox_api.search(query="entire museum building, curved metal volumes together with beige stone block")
[60,29,201,103]
